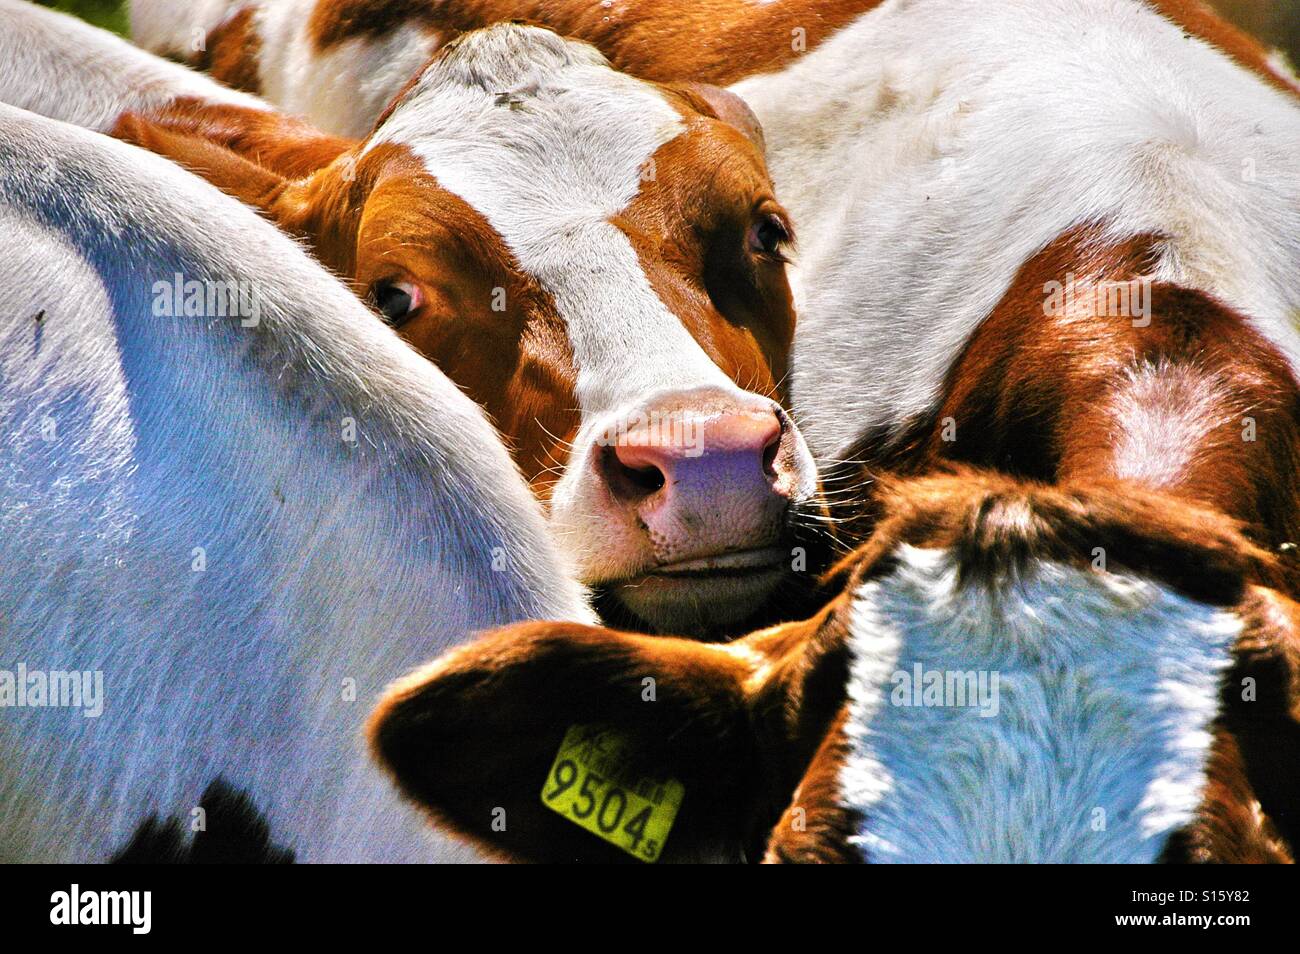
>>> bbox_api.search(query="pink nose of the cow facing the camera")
[597,399,798,565]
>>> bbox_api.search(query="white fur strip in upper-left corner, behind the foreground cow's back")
[0,0,267,131]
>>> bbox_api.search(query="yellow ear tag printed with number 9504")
[542,725,686,863]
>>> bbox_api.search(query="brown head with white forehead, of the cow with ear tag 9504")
[371,474,1300,862]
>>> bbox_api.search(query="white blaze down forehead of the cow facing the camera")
[371,23,735,416]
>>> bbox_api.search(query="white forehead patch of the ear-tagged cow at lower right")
[840,547,1240,863]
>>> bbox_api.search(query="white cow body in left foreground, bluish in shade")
[0,105,595,862]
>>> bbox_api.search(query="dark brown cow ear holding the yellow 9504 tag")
[369,623,771,862]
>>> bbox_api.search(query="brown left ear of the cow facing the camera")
[113,113,313,234]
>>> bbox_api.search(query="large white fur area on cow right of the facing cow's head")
[732,0,1300,458]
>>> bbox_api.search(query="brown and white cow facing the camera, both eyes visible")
[0,0,826,637]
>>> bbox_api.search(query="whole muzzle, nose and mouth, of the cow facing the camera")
[553,389,816,634]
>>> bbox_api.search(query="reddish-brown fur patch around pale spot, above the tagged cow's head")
[829,227,1300,594]
